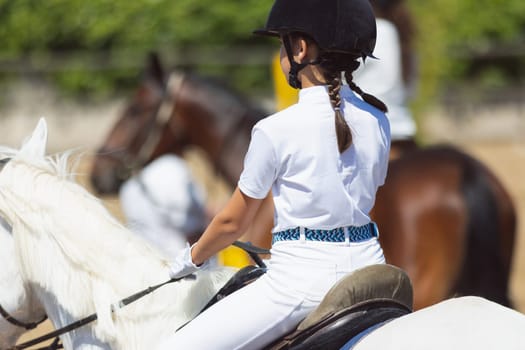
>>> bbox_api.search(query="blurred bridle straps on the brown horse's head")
[98,72,185,180]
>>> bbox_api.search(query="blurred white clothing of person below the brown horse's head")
[119,155,208,256]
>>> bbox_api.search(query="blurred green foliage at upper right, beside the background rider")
[409,0,525,117]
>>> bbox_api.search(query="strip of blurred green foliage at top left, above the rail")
[0,0,270,53]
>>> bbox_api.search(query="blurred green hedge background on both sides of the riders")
[0,0,525,113]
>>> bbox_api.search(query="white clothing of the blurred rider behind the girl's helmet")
[354,18,416,140]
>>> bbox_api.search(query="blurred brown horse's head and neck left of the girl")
[91,55,266,194]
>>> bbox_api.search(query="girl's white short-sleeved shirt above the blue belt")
[238,85,390,232]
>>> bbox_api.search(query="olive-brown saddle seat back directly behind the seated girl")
[297,264,413,331]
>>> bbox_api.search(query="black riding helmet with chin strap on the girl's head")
[254,0,376,88]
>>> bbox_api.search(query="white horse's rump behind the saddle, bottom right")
[352,296,525,350]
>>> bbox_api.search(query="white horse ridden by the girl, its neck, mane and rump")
[0,121,525,350]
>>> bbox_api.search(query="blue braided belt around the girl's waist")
[272,222,379,243]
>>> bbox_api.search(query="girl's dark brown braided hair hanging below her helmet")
[319,52,388,153]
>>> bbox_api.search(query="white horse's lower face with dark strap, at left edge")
[0,218,46,349]
